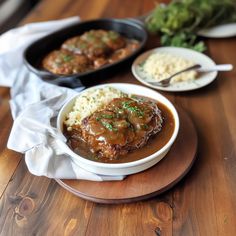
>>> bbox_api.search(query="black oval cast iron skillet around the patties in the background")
[24,18,147,88]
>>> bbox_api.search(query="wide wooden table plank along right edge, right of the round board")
[173,39,236,235]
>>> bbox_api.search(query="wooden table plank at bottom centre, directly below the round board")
[86,199,173,236]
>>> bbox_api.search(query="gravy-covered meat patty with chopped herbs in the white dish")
[81,98,163,159]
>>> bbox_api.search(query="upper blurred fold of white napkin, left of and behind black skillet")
[0,16,80,87]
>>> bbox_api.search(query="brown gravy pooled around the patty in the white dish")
[64,99,175,163]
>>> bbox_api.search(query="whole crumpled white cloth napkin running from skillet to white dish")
[0,17,125,181]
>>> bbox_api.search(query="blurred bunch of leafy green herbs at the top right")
[146,0,236,52]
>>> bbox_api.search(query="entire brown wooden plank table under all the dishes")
[0,0,236,236]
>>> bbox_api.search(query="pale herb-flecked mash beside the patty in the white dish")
[64,87,126,130]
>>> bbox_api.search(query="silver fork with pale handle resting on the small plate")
[146,64,233,87]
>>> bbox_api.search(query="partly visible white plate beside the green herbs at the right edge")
[197,23,236,38]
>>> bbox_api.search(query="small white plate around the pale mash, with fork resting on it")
[132,47,217,92]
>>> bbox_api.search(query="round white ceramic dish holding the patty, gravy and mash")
[57,83,179,175]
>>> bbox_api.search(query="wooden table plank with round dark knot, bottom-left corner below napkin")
[0,161,93,235]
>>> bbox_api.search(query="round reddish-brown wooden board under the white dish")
[56,108,197,203]
